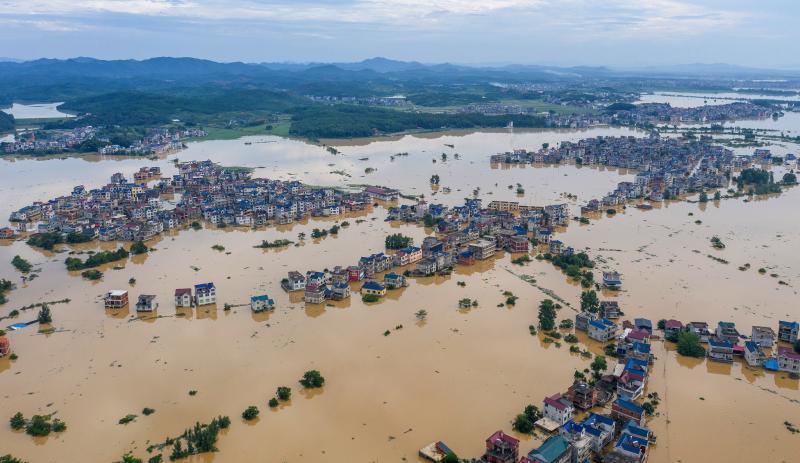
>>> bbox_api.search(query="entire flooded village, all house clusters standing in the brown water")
[0,127,800,463]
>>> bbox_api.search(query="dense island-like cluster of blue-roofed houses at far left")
[10,161,398,241]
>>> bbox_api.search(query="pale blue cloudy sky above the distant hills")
[0,0,800,69]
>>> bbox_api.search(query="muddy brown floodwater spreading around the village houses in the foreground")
[0,128,800,463]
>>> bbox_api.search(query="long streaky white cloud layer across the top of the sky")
[0,0,743,35]
